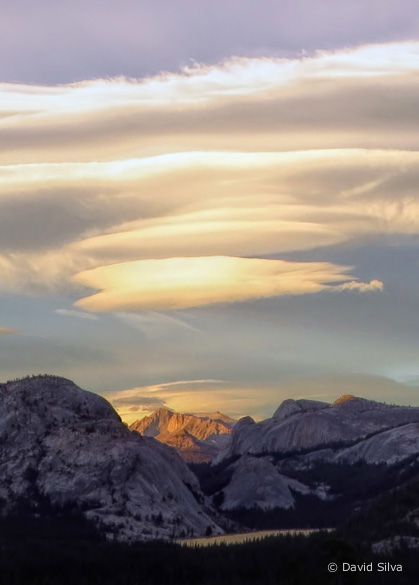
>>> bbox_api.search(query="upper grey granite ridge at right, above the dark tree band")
[215,396,419,462]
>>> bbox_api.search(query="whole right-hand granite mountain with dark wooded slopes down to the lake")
[191,395,419,528]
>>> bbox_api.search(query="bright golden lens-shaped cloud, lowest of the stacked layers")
[70,256,362,312]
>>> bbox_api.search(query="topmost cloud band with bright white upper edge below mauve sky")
[0,42,419,164]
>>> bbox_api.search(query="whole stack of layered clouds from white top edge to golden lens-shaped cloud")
[0,42,419,308]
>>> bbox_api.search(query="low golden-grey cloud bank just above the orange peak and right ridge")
[107,372,419,423]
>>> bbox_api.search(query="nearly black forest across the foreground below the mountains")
[0,480,419,585]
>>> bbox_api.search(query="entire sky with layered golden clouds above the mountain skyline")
[0,0,419,422]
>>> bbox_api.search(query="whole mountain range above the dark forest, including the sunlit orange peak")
[5,376,419,541]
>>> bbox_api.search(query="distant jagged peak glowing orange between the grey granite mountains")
[129,408,236,463]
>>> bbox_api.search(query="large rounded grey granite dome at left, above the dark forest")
[0,376,222,540]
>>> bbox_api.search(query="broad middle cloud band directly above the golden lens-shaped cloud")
[0,150,419,293]
